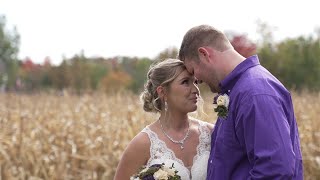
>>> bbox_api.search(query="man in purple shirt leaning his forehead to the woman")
[179,25,303,180]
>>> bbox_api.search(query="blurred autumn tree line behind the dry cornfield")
[0,16,320,94]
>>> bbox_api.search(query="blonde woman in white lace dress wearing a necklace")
[114,59,213,180]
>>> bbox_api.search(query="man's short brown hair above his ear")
[178,25,232,61]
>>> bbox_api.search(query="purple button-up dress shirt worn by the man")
[207,55,303,180]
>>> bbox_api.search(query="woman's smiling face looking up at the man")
[167,70,199,113]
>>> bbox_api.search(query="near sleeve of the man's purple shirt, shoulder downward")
[235,95,295,179]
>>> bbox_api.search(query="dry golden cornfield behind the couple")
[0,93,320,180]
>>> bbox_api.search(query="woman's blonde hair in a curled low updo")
[140,59,186,112]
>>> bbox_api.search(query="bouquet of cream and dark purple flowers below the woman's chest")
[130,163,181,180]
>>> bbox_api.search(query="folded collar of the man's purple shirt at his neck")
[219,55,260,93]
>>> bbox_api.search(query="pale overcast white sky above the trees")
[0,0,320,64]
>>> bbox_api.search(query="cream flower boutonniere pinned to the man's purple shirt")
[213,94,230,118]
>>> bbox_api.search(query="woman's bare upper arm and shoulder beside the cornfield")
[114,132,150,180]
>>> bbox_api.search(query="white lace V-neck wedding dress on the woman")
[142,120,211,180]
